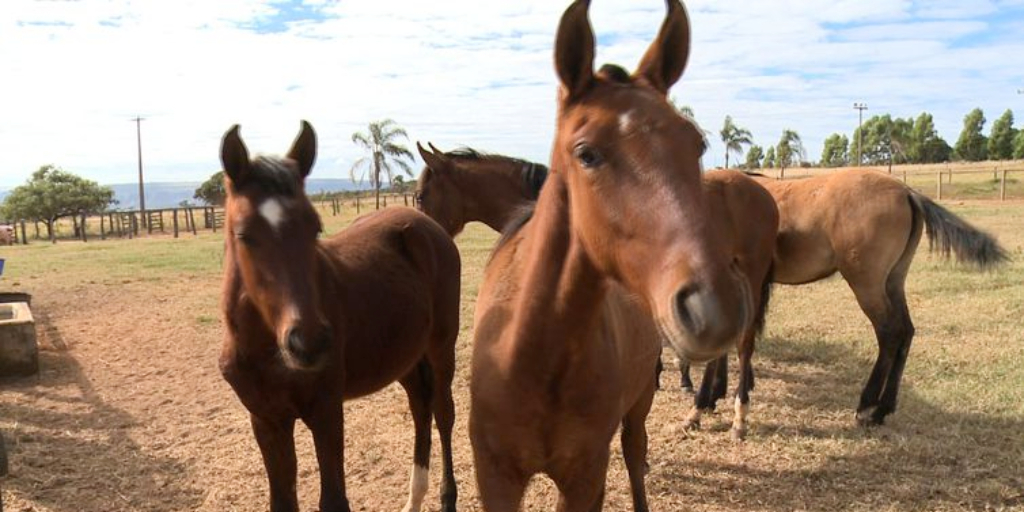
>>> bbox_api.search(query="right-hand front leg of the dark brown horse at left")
[303,398,351,512]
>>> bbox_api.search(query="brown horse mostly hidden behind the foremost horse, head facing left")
[416,144,778,438]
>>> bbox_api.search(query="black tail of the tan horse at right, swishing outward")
[910,190,1010,269]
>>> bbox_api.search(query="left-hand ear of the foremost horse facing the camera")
[555,0,596,101]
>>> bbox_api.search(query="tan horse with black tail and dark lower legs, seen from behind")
[682,170,1007,425]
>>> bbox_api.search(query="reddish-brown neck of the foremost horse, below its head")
[505,172,606,351]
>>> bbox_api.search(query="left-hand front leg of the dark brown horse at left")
[249,414,299,512]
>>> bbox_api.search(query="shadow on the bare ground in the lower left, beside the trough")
[0,305,203,512]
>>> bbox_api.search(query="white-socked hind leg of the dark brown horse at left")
[399,359,433,512]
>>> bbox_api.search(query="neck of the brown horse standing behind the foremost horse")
[458,161,530,231]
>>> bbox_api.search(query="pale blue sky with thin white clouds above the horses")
[0,0,1024,188]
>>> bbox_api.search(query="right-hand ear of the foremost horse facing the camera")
[634,0,690,95]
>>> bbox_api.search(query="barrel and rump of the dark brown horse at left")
[324,208,461,398]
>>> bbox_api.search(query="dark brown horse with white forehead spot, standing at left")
[220,122,461,512]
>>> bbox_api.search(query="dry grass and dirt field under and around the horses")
[0,201,1024,512]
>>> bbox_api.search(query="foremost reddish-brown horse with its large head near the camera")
[469,0,754,512]
